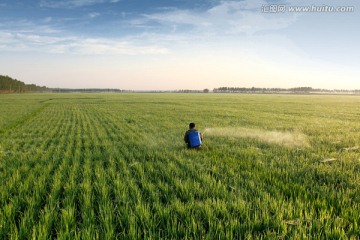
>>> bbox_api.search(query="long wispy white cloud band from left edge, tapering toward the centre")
[0,15,169,55]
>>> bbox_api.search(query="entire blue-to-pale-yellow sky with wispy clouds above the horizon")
[0,0,360,90]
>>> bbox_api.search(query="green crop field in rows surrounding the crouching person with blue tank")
[0,93,360,239]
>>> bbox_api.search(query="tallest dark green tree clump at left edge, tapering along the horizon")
[0,75,51,93]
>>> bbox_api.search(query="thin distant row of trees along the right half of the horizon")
[213,87,360,94]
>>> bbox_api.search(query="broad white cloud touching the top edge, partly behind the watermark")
[144,0,296,35]
